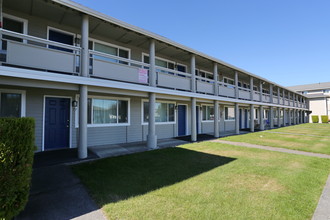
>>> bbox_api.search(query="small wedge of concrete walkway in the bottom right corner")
[312,175,330,220]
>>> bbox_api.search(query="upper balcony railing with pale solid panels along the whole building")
[0,29,306,107]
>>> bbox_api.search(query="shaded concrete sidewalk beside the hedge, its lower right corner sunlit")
[16,165,106,220]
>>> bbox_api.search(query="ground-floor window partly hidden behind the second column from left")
[143,102,175,123]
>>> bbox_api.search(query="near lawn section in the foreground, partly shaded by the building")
[72,142,330,219]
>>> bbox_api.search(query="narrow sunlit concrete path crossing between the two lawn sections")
[211,139,330,159]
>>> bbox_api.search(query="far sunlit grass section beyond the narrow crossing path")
[222,124,330,155]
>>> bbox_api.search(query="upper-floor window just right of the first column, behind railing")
[93,42,130,65]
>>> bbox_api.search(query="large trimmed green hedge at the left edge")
[0,118,35,219]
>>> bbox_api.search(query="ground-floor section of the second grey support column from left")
[147,92,157,149]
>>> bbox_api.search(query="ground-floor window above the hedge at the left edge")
[0,90,25,118]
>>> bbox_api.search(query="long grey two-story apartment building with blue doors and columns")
[0,0,307,158]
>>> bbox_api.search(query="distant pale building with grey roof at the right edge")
[288,82,330,123]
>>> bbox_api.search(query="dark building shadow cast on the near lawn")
[72,148,235,206]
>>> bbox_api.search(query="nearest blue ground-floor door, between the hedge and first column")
[44,97,70,150]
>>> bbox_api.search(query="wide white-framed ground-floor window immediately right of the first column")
[87,98,129,125]
